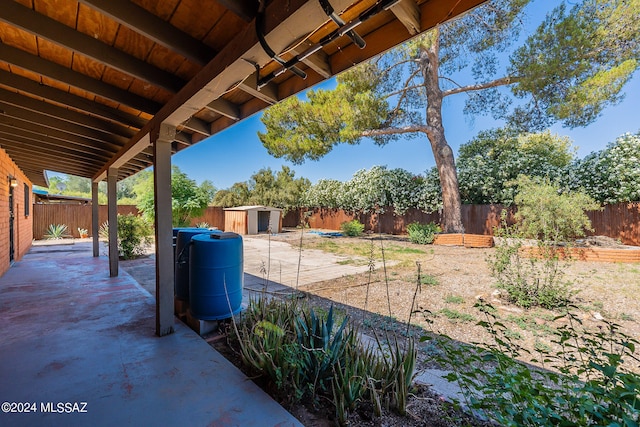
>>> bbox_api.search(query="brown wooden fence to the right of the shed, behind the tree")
[282,202,640,246]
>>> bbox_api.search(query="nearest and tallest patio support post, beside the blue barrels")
[151,123,176,336]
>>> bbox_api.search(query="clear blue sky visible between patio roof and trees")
[173,0,640,189]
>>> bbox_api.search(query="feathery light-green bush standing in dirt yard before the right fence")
[487,176,598,309]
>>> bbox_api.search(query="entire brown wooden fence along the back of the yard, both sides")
[33,202,640,246]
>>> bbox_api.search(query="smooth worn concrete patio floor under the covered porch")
[0,242,301,426]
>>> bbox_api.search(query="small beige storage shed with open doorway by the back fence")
[224,206,282,234]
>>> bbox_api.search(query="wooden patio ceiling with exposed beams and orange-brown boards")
[0,0,484,185]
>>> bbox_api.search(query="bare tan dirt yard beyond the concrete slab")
[262,231,640,372]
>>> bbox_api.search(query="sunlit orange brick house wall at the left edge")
[0,149,33,276]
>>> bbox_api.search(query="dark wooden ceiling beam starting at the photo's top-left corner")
[0,0,185,93]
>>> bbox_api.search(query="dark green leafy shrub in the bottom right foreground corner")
[423,305,640,427]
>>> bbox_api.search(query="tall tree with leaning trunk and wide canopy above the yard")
[259,0,640,231]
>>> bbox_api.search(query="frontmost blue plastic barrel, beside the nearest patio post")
[189,233,244,320]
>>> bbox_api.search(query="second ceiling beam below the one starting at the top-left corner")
[0,70,147,129]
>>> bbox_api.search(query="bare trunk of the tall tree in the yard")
[418,42,464,233]
